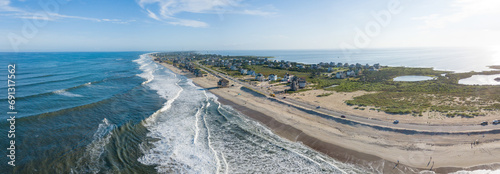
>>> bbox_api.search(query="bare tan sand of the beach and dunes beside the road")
[154,57,500,173]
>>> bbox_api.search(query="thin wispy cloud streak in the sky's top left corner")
[0,0,135,24]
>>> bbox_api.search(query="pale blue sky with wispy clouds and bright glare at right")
[0,0,500,51]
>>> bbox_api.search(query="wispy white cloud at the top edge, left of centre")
[137,0,274,27]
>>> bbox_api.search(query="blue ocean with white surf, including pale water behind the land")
[0,50,500,173]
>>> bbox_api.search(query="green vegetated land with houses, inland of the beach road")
[152,52,500,122]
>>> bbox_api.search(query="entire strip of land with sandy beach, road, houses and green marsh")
[149,52,500,173]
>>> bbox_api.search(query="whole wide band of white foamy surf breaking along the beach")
[136,53,366,173]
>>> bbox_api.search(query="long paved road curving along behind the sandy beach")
[197,62,500,133]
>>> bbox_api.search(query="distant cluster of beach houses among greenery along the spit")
[154,53,382,92]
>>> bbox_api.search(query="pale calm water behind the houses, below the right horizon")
[205,47,496,72]
